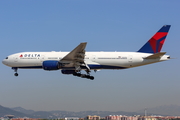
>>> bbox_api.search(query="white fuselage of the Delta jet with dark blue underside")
[3,52,169,70]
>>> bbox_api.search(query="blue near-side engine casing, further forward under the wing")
[42,60,61,71]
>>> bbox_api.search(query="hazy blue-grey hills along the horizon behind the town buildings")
[0,105,180,119]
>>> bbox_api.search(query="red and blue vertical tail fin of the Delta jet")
[138,25,171,53]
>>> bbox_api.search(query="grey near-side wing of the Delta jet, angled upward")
[60,42,89,71]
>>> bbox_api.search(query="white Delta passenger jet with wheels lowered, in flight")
[2,25,171,80]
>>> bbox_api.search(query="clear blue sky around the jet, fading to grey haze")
[0,0,180,112]
